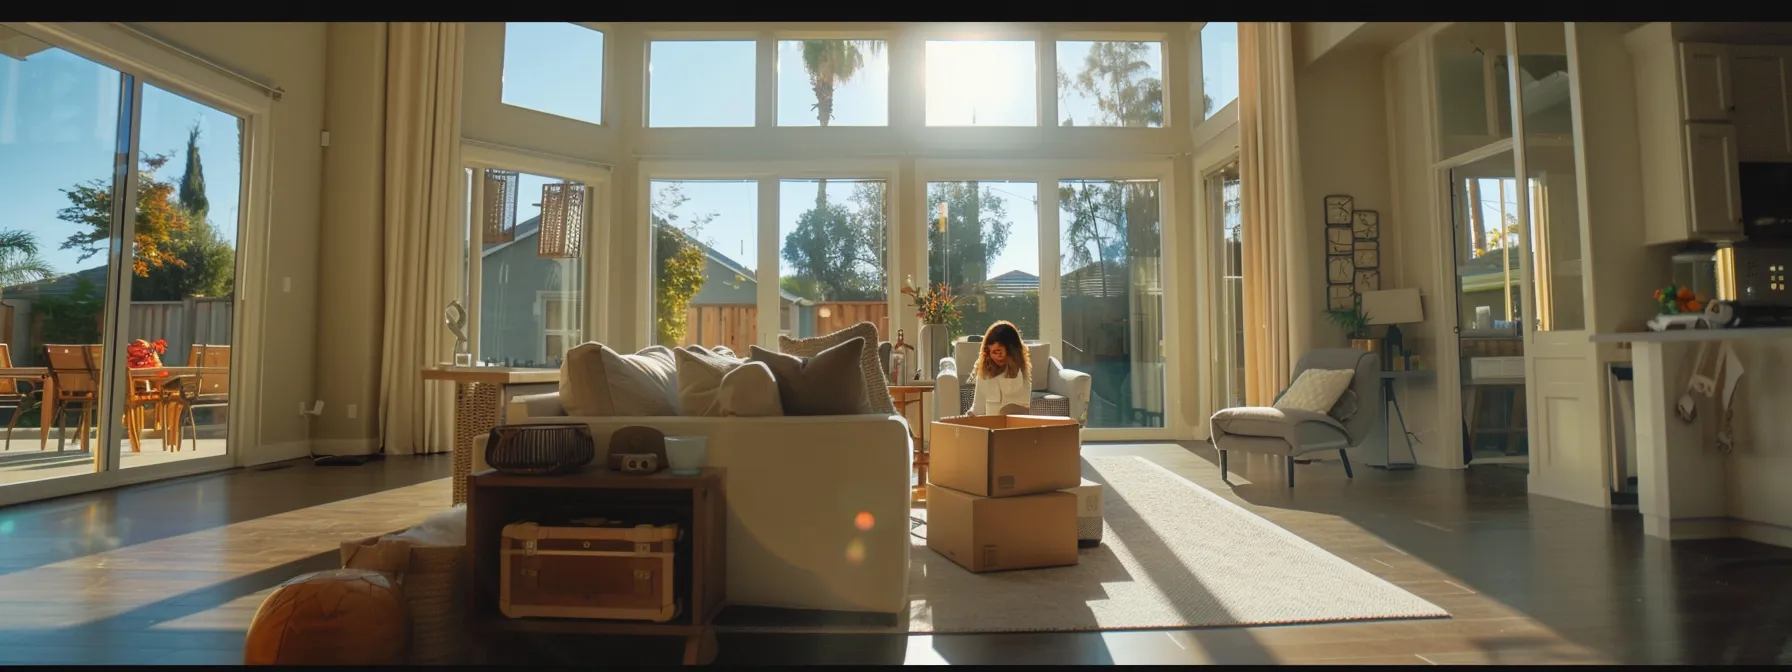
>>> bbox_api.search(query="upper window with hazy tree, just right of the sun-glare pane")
[1057,41,1163,127]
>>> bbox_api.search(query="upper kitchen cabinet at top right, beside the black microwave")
[1624,22,1734,244]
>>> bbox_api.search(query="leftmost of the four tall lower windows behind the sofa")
[649,179,760,355]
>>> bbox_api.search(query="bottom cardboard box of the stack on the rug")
[926,486,1077,572]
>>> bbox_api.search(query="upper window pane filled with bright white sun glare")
[926,39,1039,125]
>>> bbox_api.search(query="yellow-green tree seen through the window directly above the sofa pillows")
[652,183,715,348]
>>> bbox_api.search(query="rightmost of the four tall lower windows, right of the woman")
[1057,179,1165,428]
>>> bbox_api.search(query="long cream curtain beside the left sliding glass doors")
[380,23,466,453]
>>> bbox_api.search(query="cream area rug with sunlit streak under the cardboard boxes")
[720,457,1448,633]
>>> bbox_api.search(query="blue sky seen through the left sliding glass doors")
[0,48,242,281]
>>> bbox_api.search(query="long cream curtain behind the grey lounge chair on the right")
[1238,23,1319,405]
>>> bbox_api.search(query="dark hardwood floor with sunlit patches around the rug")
[0,444,1792,665]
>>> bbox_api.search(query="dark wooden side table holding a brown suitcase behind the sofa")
[462,468,728,665]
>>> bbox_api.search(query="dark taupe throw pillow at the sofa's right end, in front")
[747,337,887,416]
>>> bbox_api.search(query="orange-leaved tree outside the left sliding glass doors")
[56,154,190,278]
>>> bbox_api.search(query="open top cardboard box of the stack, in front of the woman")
[926,416,1082,496]
